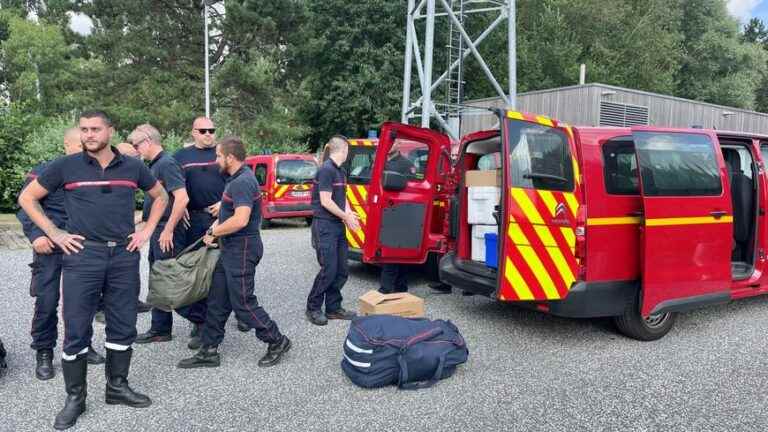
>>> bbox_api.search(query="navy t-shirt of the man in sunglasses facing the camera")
[173,146,224,210]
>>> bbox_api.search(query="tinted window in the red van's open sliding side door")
[633,132,722,196]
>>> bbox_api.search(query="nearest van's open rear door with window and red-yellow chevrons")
[496,111,581,302]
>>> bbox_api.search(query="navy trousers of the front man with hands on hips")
[62,245,141,356]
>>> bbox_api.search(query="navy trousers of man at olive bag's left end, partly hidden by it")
[149,223,208,334]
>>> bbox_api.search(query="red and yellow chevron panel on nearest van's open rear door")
[499,188,579,301]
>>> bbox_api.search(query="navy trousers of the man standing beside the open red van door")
[307,218,349,313]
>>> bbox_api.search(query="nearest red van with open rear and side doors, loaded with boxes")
[363,111,768,340]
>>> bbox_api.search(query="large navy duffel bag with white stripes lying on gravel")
[341,315,469,389]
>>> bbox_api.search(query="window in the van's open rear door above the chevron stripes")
[509,121,574,192]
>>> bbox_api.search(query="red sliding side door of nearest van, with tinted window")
[632,127,733,317]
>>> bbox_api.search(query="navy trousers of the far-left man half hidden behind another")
[29,250,63,350]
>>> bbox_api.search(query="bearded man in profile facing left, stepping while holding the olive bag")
[178,137,291,369]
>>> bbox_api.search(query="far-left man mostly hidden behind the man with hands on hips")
[16,128,104,380]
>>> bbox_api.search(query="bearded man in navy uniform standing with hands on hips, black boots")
[19,111,168,430]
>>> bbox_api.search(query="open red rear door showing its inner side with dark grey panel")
[363,123,450,264]
